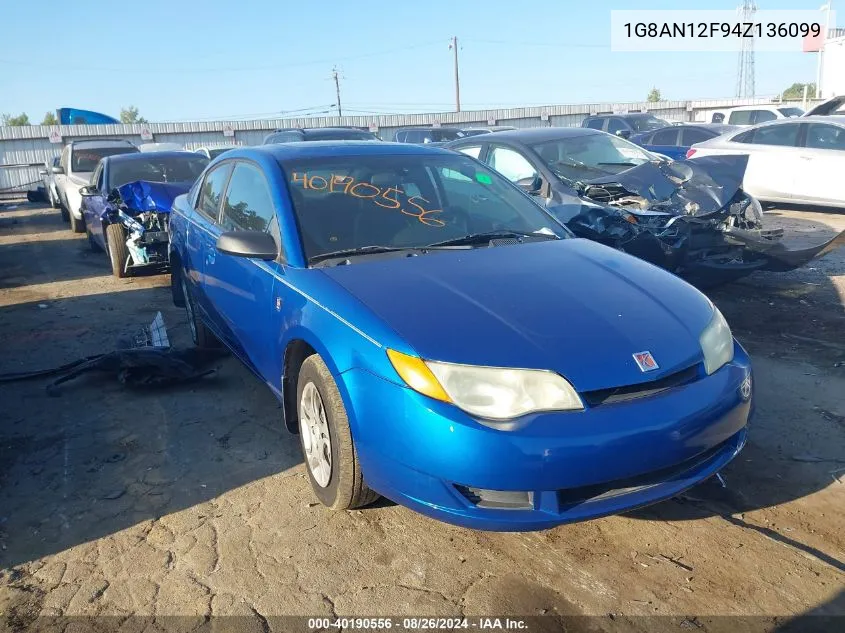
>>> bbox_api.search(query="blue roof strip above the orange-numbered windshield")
[224,141,452,161]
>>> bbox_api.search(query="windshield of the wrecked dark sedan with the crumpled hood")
[532,133,654,181]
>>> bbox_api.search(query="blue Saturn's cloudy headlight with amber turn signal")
[387,350,584,420]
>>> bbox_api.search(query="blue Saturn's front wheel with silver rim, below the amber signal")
[296,354,379,510]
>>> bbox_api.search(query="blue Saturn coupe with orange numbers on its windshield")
[170,142,752,530]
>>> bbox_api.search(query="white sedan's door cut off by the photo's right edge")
[793,123,845,206]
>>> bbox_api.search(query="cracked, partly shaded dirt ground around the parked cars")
[0,205,845,631]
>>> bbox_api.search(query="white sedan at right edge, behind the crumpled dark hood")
[687,115,845,208]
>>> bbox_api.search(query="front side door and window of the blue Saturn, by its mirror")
[205,161,284,380]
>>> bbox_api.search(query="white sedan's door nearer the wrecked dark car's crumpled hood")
[742,123,803,202]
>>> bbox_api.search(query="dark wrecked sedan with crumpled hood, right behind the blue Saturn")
[448,128,845,286]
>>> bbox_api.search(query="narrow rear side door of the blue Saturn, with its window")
[185,161,234,336]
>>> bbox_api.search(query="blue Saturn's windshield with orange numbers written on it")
[282,154,568,261]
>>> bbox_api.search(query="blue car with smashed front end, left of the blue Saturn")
[79,151,209,277]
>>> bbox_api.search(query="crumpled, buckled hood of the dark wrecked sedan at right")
[579,155,748,216]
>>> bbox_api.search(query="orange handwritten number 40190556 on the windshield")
[291,172,446,227]
